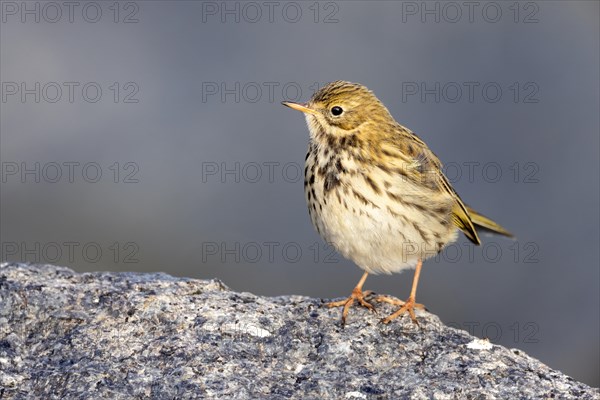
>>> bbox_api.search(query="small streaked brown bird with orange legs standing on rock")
[282,81,512,324]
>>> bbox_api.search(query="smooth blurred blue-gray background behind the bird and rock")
[0,1,600,386]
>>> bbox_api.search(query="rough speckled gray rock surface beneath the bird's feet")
[0,263,599,399]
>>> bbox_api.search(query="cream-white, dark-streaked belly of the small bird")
[306,154,458,274]
